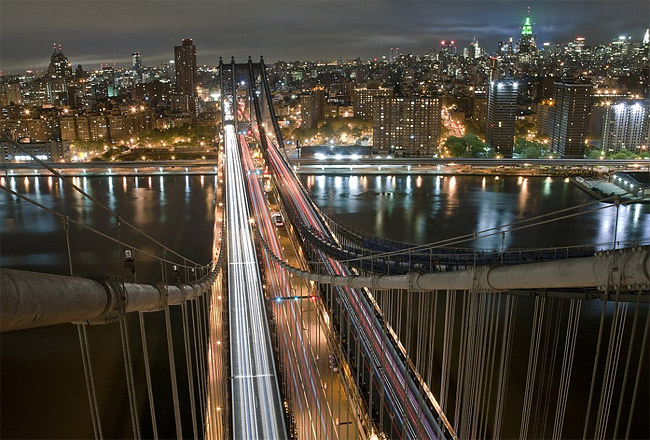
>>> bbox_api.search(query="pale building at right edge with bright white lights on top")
[602,100,650,153]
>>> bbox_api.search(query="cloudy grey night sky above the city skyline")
[0,0,650,72]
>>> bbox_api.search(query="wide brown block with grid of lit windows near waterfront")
[372,96,442,157]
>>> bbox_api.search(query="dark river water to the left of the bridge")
[0,175,215,438]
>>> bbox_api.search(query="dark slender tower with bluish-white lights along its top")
[485,77,519,157]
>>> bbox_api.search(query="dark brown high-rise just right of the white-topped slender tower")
[550,80,592,158]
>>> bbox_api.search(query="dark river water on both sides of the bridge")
[0,175,650,438]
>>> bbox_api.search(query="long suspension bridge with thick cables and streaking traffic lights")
[0,59,650,439]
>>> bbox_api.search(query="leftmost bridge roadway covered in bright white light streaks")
[224,102,287,439]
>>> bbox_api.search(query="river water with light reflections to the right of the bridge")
[301,175,650,249]
